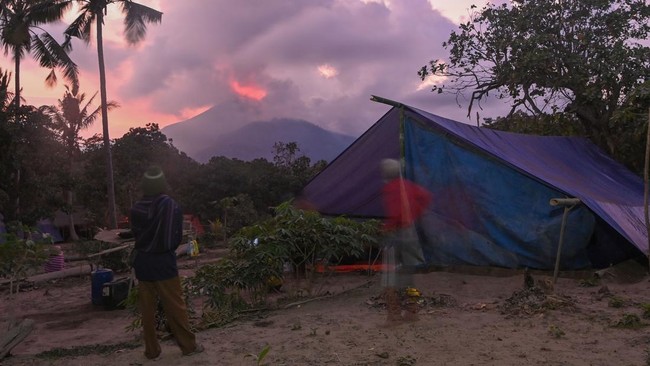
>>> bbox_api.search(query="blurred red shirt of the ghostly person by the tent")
[382,178,432,231]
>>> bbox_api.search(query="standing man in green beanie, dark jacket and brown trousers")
[131,166,204,359]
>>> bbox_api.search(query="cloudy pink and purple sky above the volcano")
[0,0,506,138]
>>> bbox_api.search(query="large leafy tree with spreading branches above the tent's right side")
[419,0,650,156]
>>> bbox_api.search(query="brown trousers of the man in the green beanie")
[138,276,196,358]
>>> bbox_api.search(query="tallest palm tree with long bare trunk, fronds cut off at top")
[65,0,162,229]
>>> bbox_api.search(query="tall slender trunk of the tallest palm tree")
[96,11,117,229]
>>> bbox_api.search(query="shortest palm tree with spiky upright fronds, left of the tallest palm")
[42,85,117,240]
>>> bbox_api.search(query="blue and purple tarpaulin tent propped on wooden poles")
[303,97,647,269]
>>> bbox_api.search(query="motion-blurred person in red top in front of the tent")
[380,159,432,322]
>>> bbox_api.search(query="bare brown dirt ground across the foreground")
[0,247,650,366]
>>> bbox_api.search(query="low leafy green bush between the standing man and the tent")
[188,202,379,326]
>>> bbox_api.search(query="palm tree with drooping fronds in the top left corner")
[0,0,79,109]
